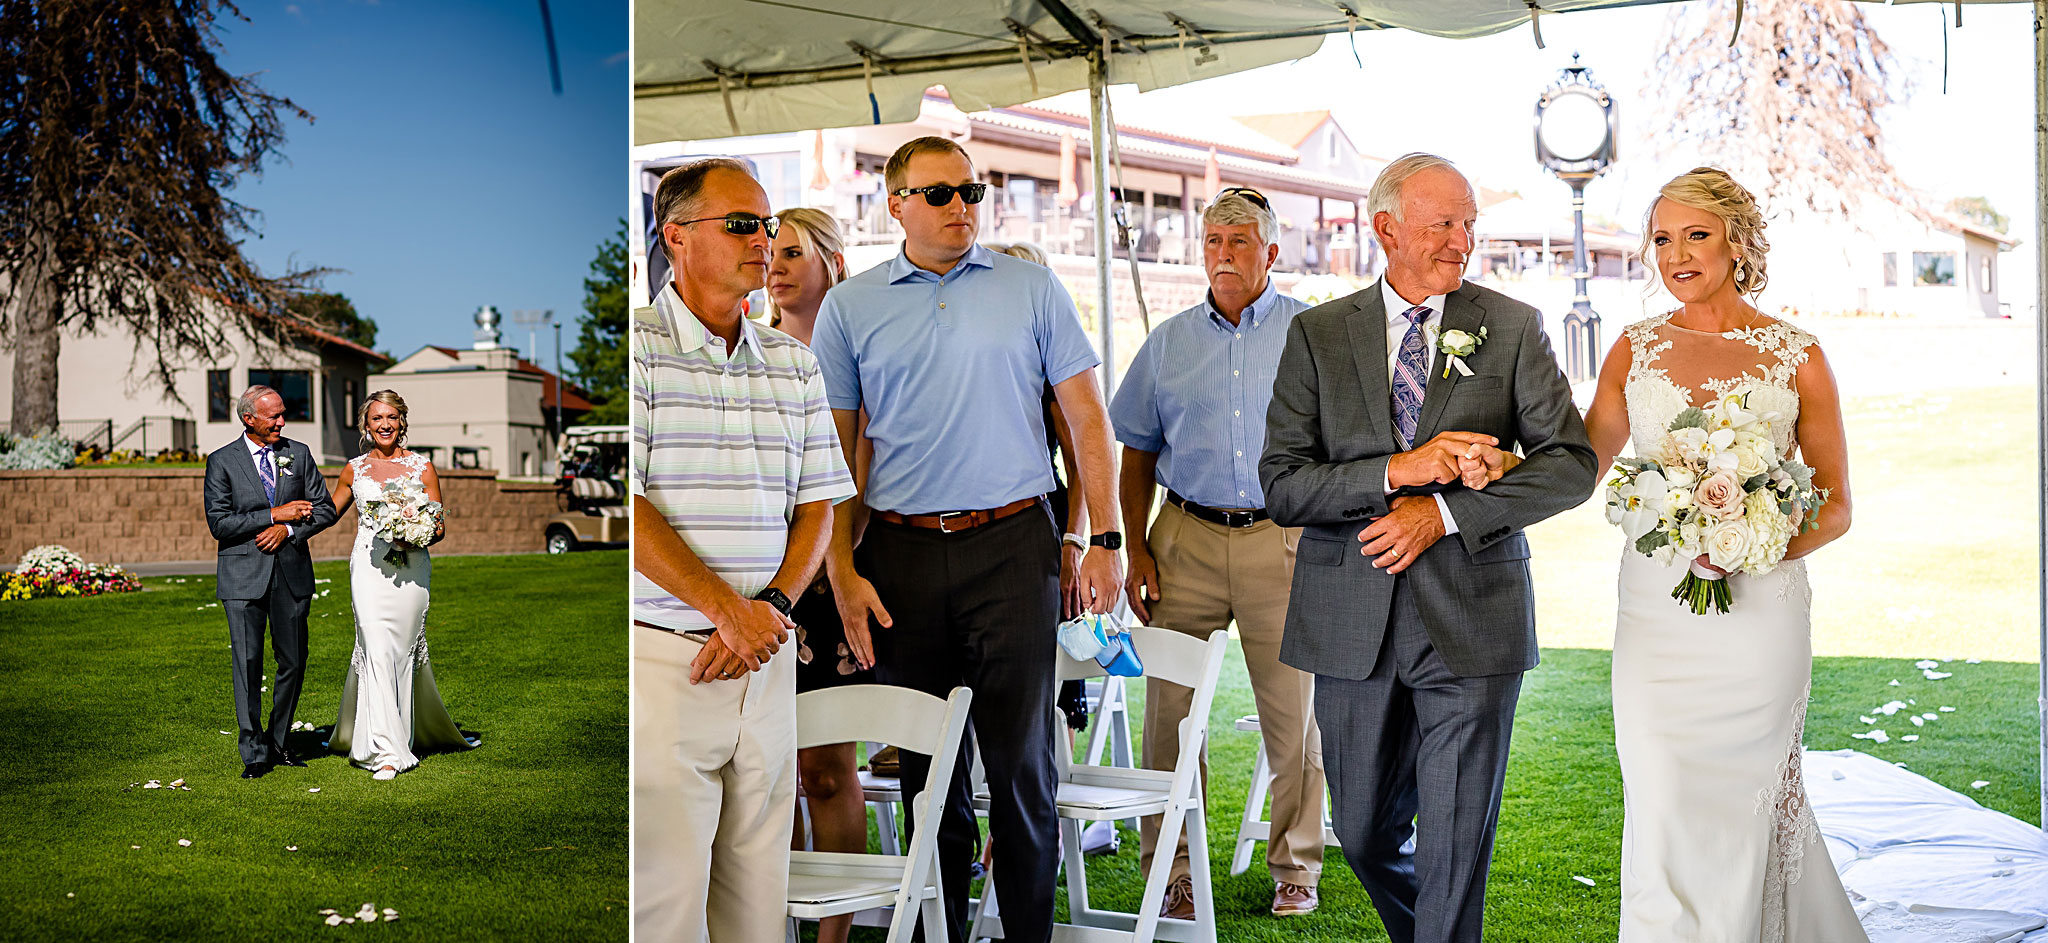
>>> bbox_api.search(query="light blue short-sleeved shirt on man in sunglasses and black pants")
[811,246,1105,515]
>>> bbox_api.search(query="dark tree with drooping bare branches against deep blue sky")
[0,0,319,433]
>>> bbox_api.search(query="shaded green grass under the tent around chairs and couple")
[892,646,2040,943]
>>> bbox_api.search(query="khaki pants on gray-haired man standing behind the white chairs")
[1139,504,1323,888]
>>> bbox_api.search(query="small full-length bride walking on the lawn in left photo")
[328,390,475,779]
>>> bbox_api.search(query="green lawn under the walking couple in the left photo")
[0,551,627,941]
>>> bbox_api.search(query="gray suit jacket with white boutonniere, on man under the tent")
[1260,283,1595,681]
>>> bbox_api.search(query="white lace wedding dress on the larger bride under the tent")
[1614,316,1866,943]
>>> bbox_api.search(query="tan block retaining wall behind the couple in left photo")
[0,467,557,568]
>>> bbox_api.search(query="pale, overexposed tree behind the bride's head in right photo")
[1649,0,1919,219]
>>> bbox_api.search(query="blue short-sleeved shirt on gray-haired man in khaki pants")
[1110,281,1309,508]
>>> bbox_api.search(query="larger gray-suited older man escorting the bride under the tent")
[1260,154,1595,943]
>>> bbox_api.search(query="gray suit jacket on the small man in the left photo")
[205,435,334,599]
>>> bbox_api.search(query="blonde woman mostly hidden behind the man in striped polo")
[768,207,874,943]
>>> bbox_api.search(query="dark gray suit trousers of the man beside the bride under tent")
[1315,580,1522,943]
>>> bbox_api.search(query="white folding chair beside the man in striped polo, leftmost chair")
[788,685,973,943]
